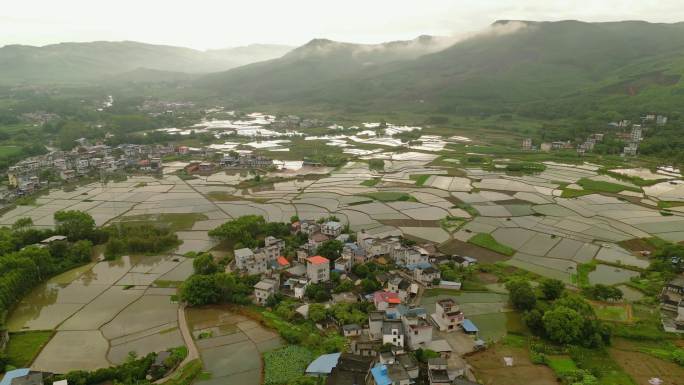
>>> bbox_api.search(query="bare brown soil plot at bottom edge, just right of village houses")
[466,345,558,385]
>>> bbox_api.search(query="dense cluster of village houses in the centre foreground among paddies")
[227,220,485,385]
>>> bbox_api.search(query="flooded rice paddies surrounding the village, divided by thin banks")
[0,154,684,370]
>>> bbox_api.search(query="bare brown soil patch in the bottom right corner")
[610,340,684,385]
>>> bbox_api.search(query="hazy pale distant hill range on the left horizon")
[0,41,291,84]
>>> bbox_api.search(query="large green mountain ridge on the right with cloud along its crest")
[197,21,684,117]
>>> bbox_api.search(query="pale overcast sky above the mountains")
[0,0,684,49]
